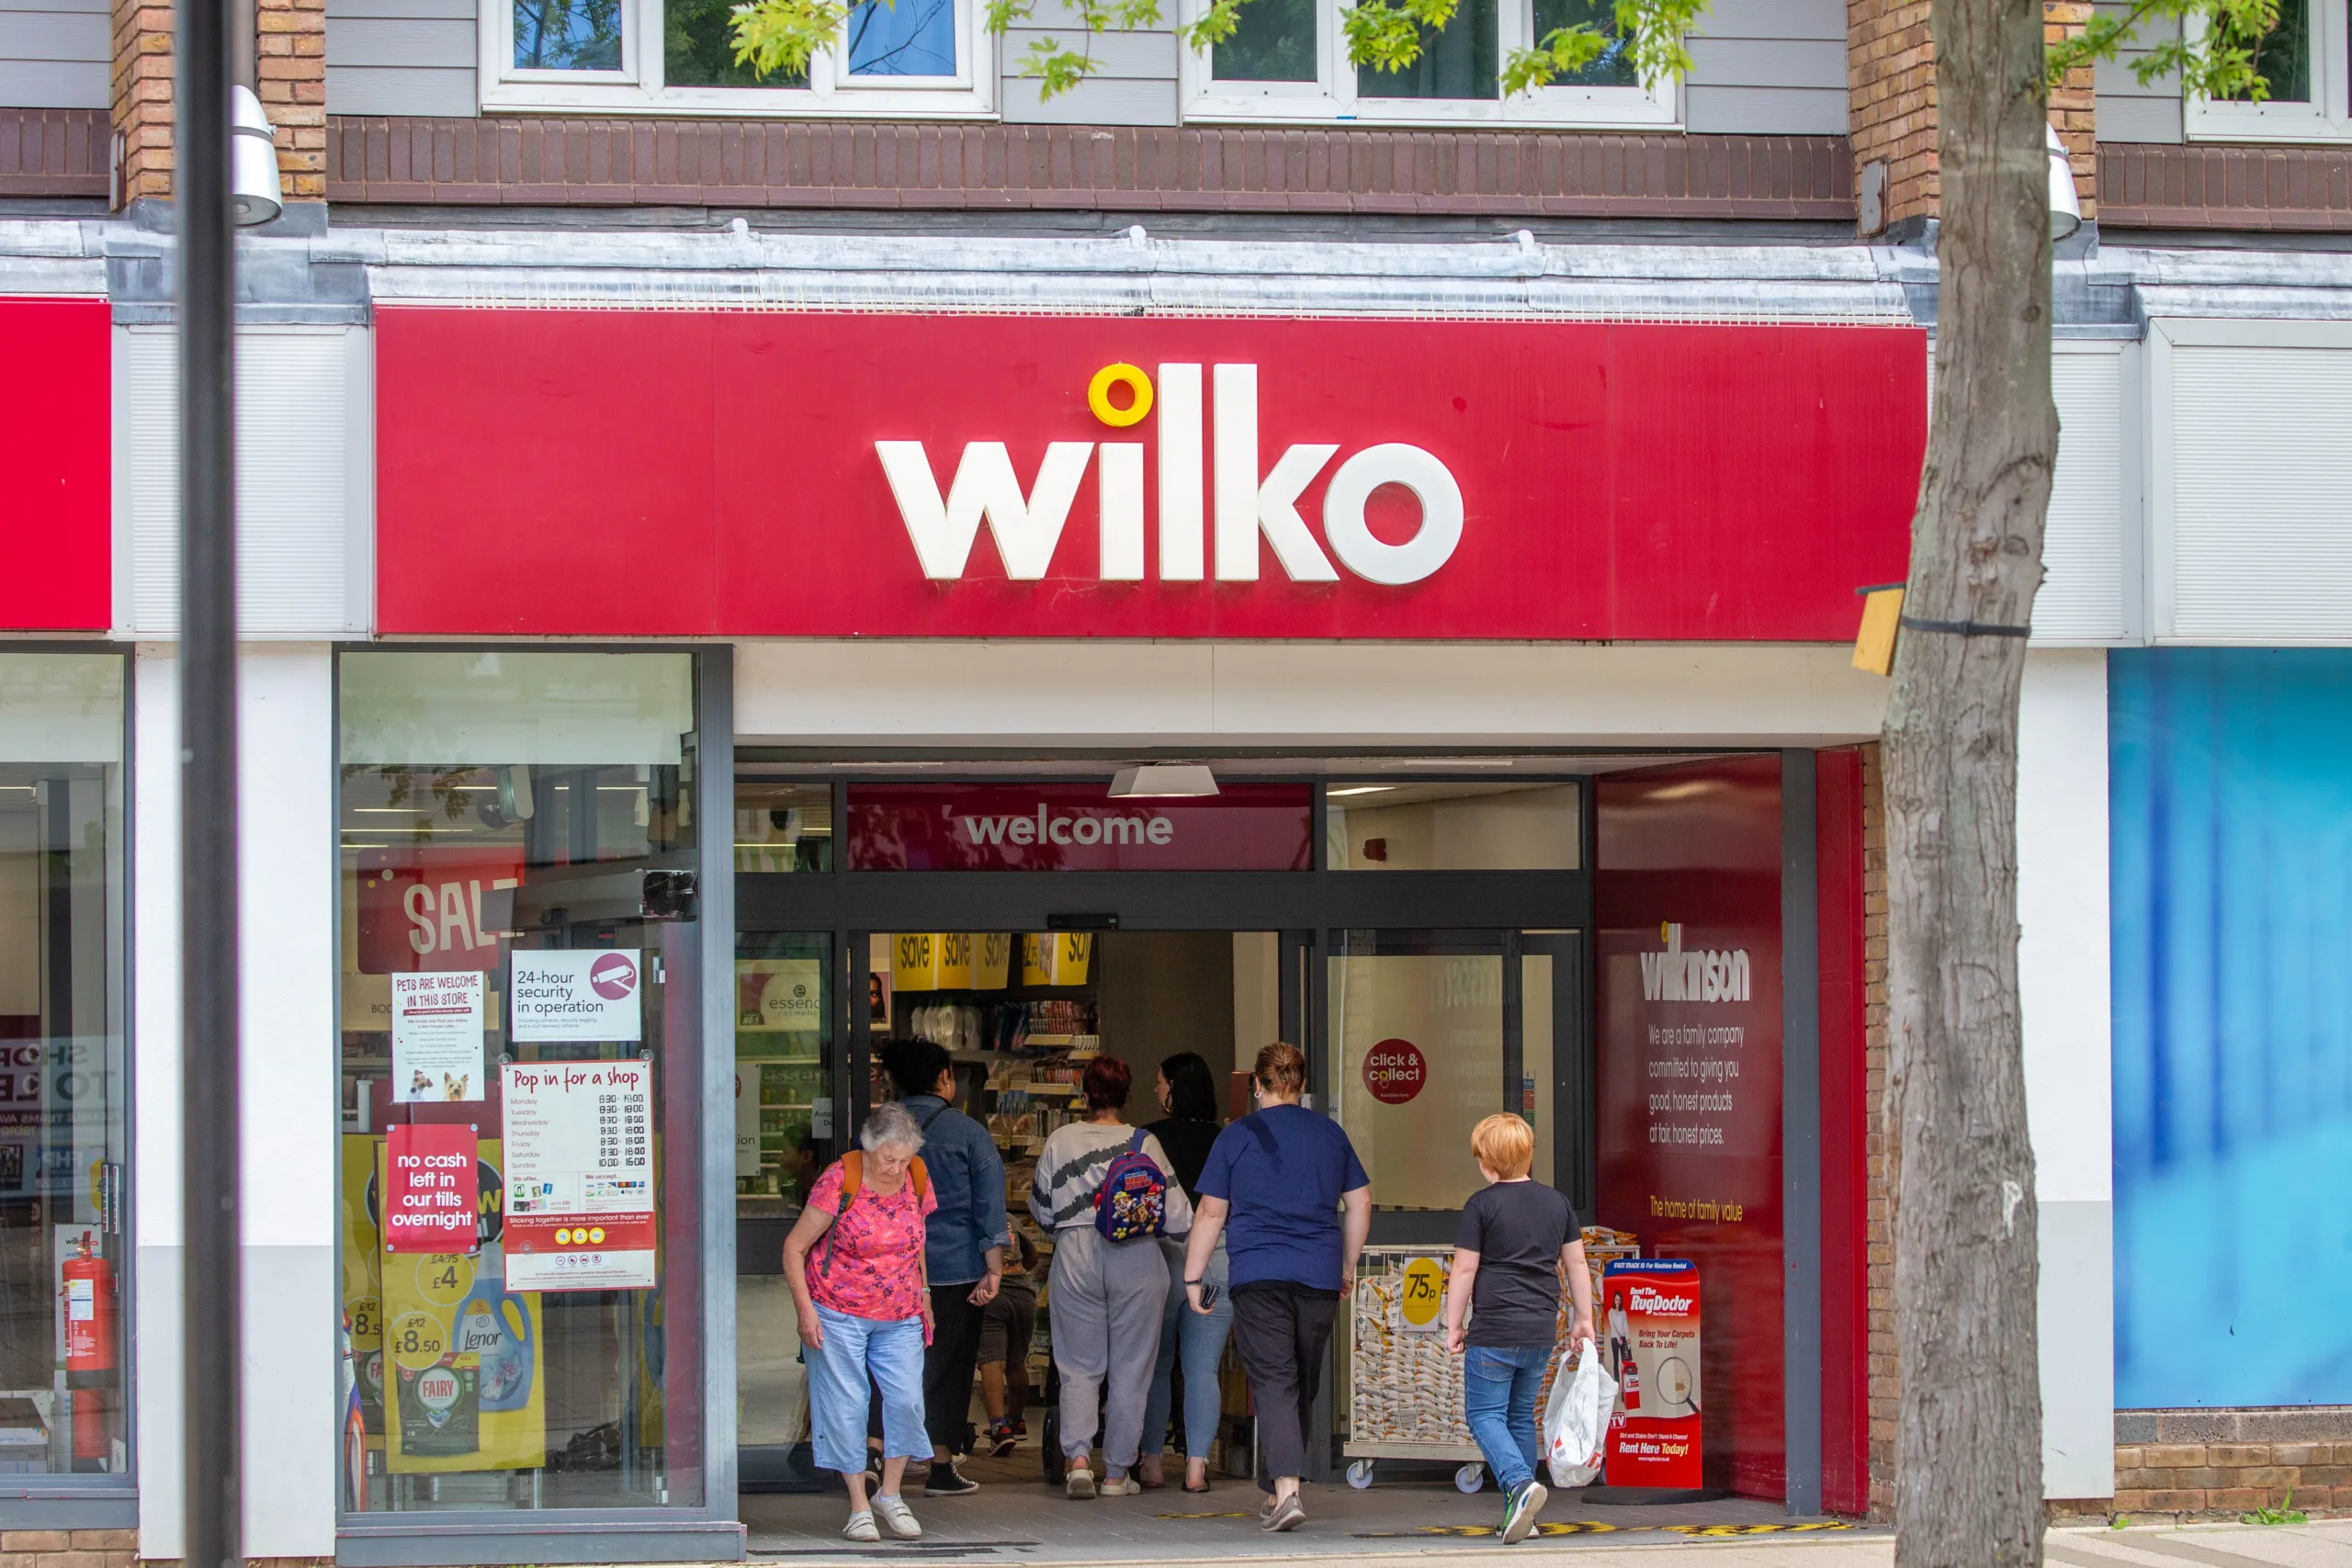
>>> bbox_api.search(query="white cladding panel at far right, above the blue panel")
[2150,320,2352,644]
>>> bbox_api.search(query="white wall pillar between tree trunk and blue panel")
[2018,649,2114,1497]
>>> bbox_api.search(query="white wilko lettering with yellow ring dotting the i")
[875,365,1463,588]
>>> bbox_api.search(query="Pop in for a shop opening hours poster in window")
[503,1060,656,1291]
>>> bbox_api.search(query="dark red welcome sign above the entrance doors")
[849,785,1312,872]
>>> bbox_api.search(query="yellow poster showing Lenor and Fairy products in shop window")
[374,1138,548,1474]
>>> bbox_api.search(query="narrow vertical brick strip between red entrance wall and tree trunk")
[1863,743,1900,1518]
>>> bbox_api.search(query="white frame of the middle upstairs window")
[1179,0,1683,131]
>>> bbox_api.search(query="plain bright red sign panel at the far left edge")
[0,299,113,632]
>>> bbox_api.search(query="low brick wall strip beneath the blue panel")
[2114,1405,2352,1518]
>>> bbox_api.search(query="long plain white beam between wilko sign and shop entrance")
[736,642,1886,755]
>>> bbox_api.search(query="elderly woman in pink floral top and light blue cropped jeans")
[783,1105,938,1540]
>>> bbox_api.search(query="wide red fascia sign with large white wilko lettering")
[377,306,1927,642]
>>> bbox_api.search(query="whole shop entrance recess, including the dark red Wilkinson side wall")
[736,757,1825,1554]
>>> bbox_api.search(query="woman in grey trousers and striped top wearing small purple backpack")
[1030,1055,1193,1497]
